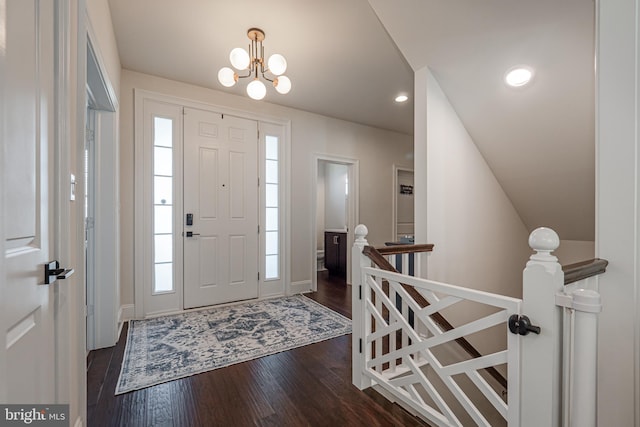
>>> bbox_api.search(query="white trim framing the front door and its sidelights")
[134,88,291,319]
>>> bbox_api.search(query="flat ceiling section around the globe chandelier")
[109,0,413,134]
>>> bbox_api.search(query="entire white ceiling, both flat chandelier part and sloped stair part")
[109,0,594,240]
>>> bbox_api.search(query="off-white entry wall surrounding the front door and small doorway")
[120,70,413,304]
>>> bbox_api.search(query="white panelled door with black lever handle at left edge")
[0,0,56,404]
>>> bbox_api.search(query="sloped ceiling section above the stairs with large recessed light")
[369,0,595,240]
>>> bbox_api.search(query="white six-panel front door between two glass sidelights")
[183,108,259,308]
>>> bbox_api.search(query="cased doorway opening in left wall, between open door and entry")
[84,38,120,350]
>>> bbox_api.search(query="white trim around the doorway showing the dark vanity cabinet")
[310,153,360,291]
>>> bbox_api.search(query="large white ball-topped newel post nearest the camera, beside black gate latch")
[520,227,564,427]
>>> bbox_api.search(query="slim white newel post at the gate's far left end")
[351,224,371,390]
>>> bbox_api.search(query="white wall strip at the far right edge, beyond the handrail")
[596,0,640,426]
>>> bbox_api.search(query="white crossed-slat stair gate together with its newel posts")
[352,225,606,426]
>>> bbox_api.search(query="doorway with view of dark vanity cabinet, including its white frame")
[311,155,358,291]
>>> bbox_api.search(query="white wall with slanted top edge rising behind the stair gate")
[415,68,530,297]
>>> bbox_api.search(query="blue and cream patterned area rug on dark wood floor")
[116,295,351,394]
